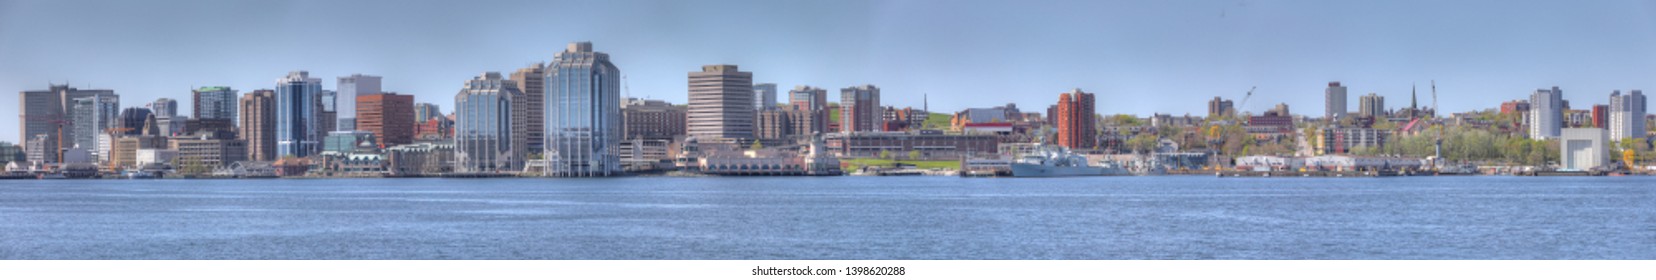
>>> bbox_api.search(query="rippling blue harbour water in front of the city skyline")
[0,176,1656,260]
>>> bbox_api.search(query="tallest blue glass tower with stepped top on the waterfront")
[545,41,621,177]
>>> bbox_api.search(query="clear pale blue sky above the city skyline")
[0,0,1656,142]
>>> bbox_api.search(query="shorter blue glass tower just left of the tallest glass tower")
[453,71,528,172]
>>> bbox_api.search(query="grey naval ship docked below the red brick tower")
[1012,146,1133,177]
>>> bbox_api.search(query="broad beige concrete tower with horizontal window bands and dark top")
[689,65,755,142]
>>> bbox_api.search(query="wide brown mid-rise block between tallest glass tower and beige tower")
[621,98,689,139]
